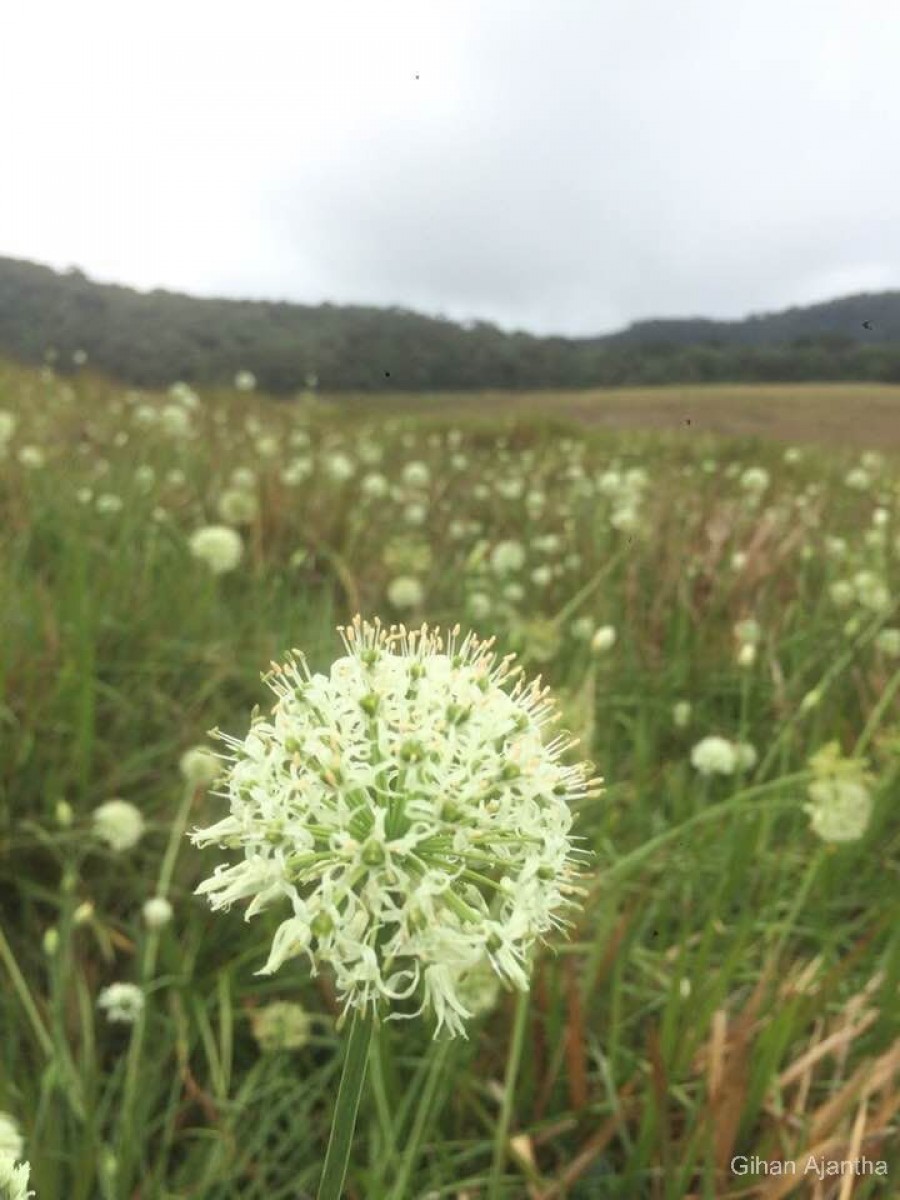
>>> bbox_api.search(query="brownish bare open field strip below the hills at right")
[343,383,900,451]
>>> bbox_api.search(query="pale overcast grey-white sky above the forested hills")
[0,0,900,334]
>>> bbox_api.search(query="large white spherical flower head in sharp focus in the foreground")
[191,618,599,1034]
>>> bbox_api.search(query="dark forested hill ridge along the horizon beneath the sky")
[0,258,900,394]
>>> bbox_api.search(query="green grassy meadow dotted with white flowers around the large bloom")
[0,366,900,1200]
